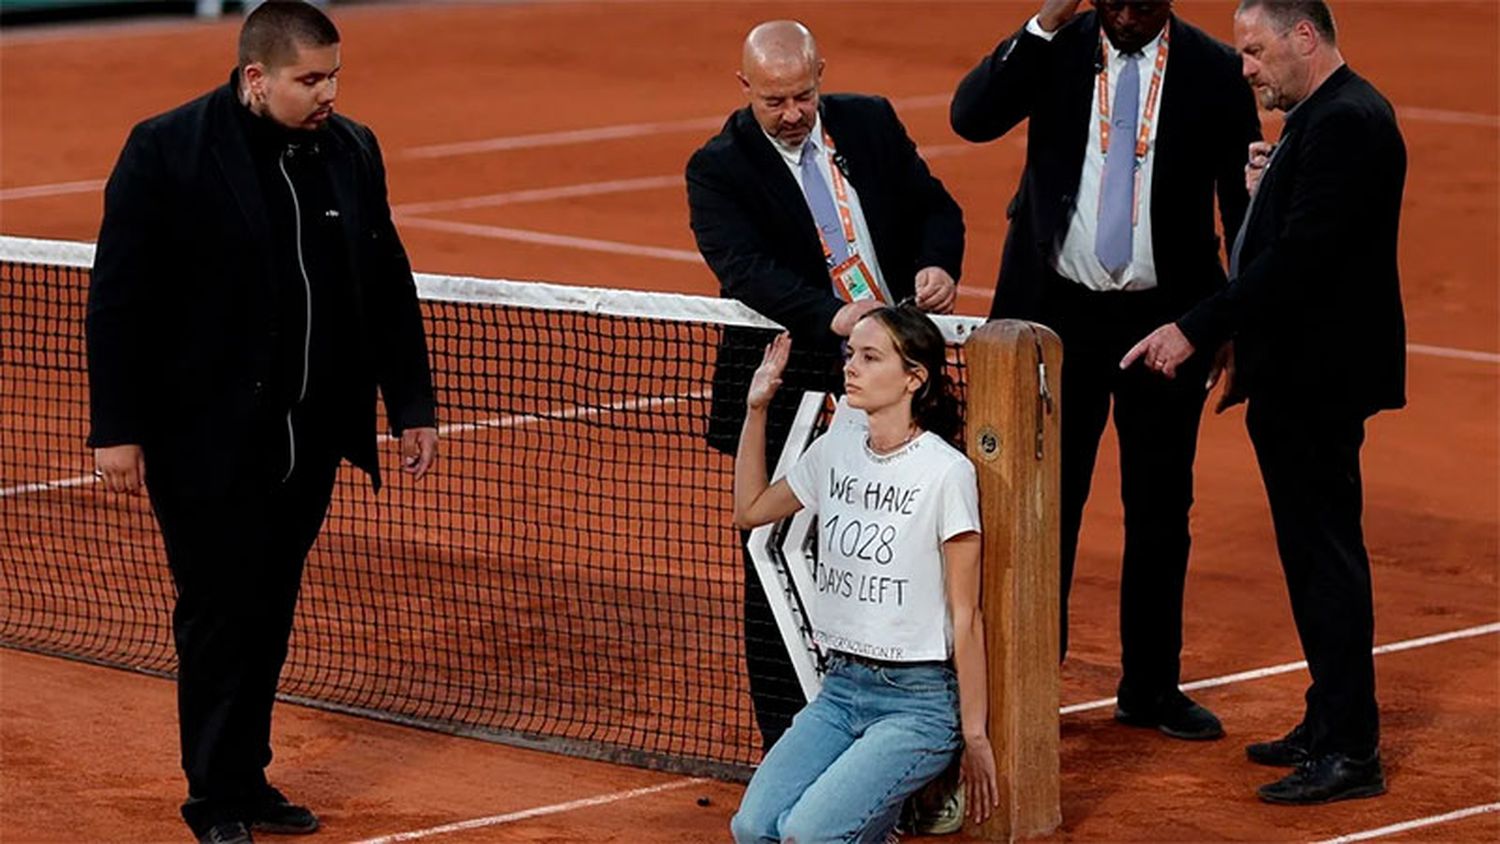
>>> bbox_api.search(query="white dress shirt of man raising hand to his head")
[1026,18,1172,291]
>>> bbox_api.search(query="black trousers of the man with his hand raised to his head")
[1043,274,1211,708]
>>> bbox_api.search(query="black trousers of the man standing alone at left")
[146,420,338,834]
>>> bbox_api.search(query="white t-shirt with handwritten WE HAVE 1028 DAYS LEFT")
[786,414,980,663]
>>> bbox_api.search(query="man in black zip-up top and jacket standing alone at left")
[87,1,438,844]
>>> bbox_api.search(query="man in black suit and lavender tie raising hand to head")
[951,0,1260,739]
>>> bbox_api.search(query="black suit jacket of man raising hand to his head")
[950,12,1260,319]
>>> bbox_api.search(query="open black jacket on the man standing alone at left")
[87,79,435,487]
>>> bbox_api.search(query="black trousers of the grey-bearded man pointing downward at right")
[1245,397,1380,759]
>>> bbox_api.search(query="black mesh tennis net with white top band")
[0,238,972,777]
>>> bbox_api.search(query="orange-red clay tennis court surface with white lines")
[0,0,1500,843]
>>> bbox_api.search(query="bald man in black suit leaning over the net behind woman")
[687,21,963,748]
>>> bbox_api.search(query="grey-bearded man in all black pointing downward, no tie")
[1122,0,1406,804]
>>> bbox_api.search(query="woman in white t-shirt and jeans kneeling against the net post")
[731,306,999,844]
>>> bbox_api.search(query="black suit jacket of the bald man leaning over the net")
[687,94,963,453]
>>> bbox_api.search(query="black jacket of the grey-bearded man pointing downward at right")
[1178,66,1407,415]
